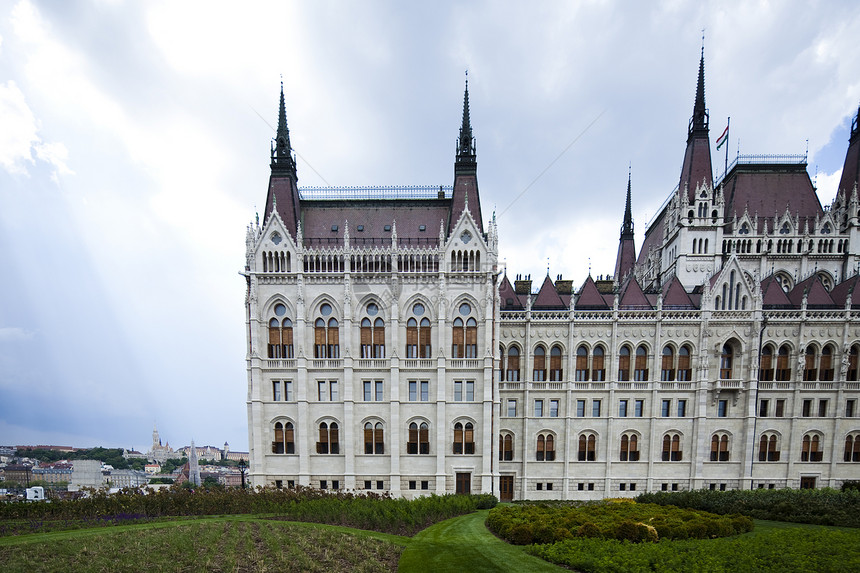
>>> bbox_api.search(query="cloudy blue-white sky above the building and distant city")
[0,0,860,451]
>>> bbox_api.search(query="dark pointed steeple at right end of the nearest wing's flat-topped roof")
[448,72,484,235]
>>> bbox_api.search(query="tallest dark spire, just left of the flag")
[678,46,714,202]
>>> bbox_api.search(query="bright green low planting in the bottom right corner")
[526,528,860,573]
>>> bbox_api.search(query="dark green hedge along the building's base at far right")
[636,488,860,527]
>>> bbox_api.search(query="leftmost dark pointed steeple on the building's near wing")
[263,82,301,238]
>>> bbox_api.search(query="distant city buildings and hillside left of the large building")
[0,422,248,495]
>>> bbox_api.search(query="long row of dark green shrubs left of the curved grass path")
[0,487,497,535]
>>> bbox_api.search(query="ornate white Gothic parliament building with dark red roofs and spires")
[242,54,860,500]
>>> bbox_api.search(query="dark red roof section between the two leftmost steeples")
[300,199,450,245]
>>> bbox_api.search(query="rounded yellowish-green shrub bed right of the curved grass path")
[487,503,753,545]
